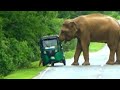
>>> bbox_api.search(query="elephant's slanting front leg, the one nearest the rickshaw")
[72,40,82,65]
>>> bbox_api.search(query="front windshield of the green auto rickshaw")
[43,39,57,49]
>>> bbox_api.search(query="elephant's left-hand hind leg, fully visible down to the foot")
[106,44,116,65]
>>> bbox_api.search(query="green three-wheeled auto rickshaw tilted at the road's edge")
[40,35,66,66]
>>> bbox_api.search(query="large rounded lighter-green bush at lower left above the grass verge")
[0,38,35,76]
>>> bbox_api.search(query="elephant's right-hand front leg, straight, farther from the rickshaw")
[81,41,90,65]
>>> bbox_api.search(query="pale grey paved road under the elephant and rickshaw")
[33,46,120,79]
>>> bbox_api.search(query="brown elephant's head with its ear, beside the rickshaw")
[59,19,77,42]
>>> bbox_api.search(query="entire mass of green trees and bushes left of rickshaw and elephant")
[0,11,63,75]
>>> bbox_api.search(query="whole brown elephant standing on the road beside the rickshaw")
[59,13,120,65]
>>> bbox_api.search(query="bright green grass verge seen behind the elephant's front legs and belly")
[65,42,105,59]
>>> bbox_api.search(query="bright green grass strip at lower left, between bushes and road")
[4,61,46,79]
